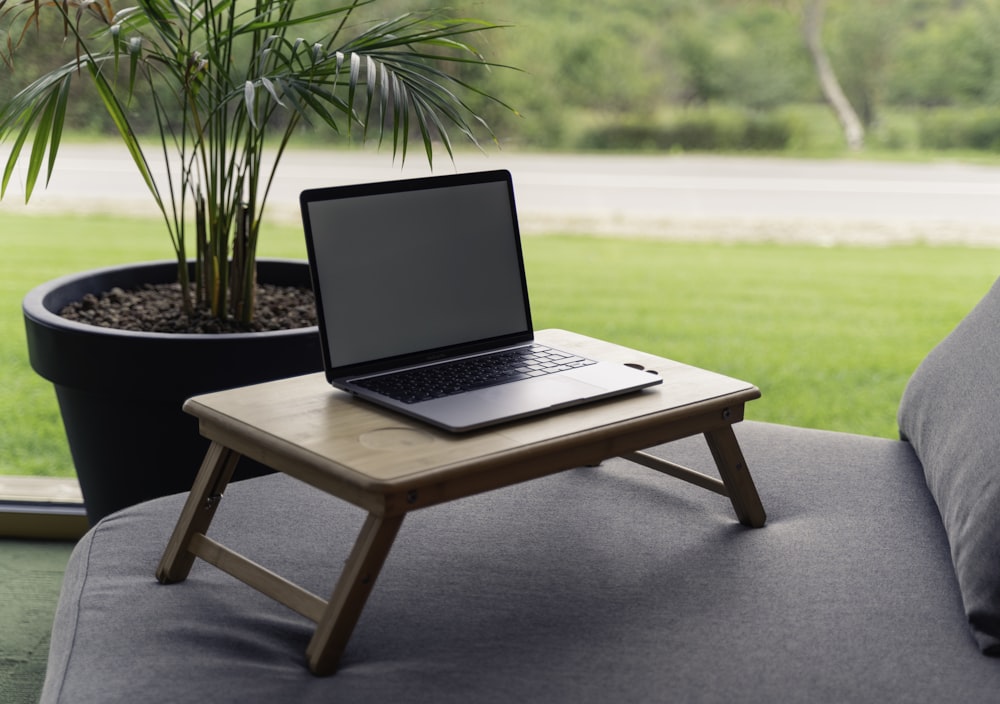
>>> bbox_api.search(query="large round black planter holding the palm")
[24,260,322,524]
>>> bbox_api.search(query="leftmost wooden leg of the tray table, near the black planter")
[156,442,240,584]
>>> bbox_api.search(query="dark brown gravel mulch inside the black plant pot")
[60,283,316,333]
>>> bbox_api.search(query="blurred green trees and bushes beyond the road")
[7,0,1000,152]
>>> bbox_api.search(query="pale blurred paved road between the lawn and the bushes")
[0,144,1000,246]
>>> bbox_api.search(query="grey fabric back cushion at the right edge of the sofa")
[899,281,1000,655]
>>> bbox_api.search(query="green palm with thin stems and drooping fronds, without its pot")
[0,0,512,323]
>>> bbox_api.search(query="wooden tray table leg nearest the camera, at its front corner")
[306,513,405,675]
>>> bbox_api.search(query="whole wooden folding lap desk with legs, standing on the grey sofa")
[157,330,765,675]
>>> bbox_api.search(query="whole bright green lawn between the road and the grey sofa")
[0,212,1000,476]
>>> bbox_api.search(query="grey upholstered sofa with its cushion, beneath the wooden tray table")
[41,282,1000,704]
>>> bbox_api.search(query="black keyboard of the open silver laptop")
[354,345,594,403]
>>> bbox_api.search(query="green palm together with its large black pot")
[0,0,512,521]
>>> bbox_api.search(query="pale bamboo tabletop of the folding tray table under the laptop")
[185,331,760,500]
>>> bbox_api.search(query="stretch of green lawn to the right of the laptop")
[526,237,1000,437]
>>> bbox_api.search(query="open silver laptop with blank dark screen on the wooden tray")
[300,170,661,432]
